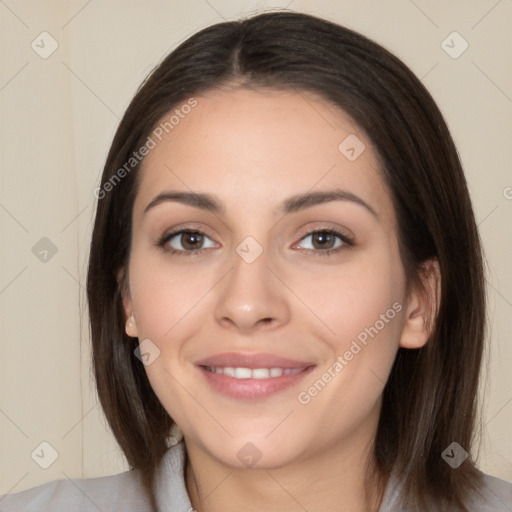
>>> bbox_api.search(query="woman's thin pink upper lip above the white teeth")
[196,352,314,369]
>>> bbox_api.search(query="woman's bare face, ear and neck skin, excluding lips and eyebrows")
[124,89,438,512]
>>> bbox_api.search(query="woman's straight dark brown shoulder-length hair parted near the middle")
[87,11,485,511]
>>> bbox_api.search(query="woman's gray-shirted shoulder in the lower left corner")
[0,470,150,512]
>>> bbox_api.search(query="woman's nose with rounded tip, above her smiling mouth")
[214,252,290,334]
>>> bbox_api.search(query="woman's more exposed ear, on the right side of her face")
[399,259,441,348]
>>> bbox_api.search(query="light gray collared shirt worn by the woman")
[0,441,512,512]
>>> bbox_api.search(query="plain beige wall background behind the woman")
[0,0,512,493]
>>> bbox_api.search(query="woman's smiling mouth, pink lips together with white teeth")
[196,353,316,401]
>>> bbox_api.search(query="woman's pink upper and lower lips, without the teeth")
[196,352,316,401]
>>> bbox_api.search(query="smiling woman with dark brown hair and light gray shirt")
[0,8,512,512]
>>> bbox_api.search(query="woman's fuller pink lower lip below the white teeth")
[199,366,314,400]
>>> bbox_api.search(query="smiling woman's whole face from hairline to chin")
[124,89,417,467]
